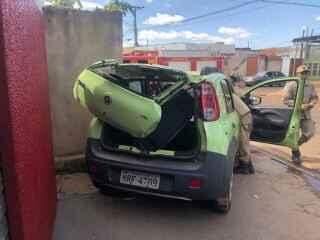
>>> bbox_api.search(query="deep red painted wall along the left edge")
[0,0,56,240]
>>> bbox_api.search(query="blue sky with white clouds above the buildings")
[77,0,320,49]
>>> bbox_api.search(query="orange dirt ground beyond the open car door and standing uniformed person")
[240,83,320,171]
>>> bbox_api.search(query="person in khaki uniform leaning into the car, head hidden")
[233,93,254,174]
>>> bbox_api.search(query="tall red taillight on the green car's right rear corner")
[200,82,220,121]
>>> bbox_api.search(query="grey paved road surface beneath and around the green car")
[54,150,320,240]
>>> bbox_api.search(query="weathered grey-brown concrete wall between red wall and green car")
[43,7,122,156]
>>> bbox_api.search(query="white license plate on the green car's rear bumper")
[120,170,160,189]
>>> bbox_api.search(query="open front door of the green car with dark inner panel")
[242,78,304,148]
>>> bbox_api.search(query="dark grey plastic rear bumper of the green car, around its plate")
[86,139,232,200]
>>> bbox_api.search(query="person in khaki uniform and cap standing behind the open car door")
[283,65,319,164]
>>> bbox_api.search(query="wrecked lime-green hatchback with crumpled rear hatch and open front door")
[74,60,304,212]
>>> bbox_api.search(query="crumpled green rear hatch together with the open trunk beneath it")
[74,61,199,155]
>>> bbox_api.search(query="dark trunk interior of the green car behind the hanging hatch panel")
[94,64,200,158]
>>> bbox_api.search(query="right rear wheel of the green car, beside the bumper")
[212,173,233,214]
